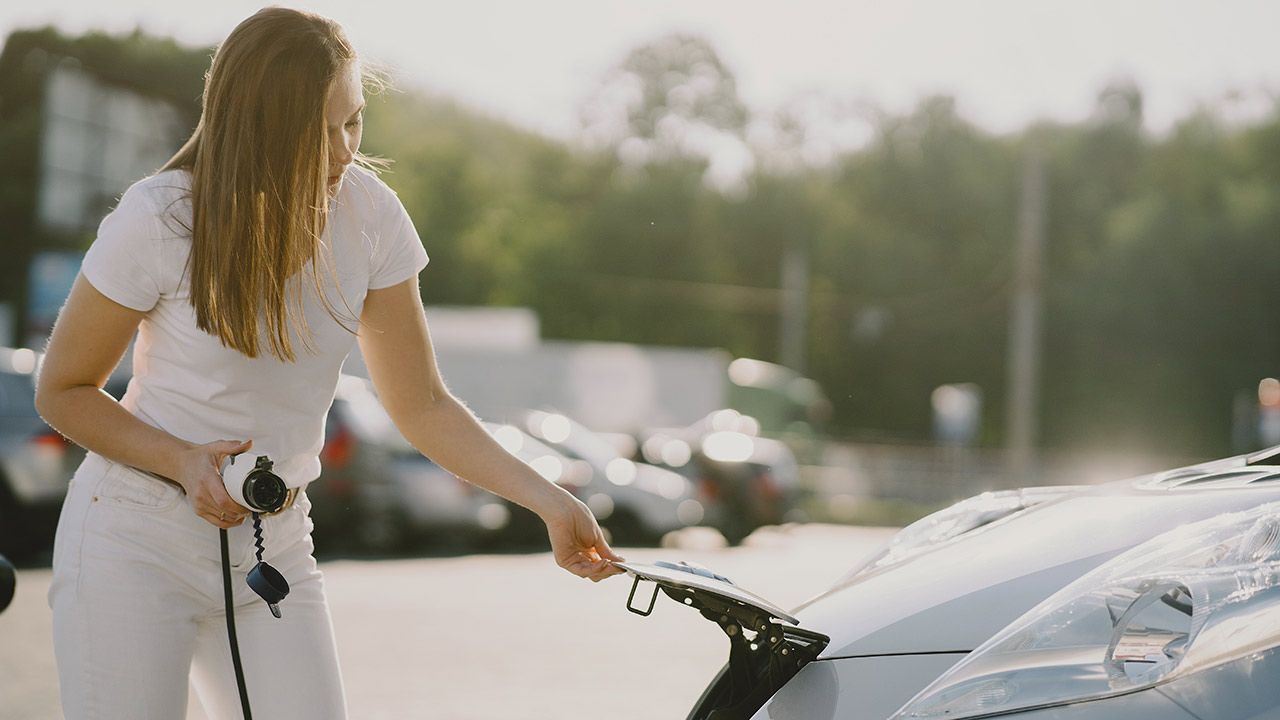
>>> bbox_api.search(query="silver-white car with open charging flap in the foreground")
[622,448,1280,720]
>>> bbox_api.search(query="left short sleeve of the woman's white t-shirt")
[81,187,160,313]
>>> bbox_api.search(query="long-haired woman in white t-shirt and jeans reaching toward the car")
[36,8,620,720]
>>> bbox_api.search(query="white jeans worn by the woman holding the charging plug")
[49,452,346,720]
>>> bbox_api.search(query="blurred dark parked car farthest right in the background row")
[636,409,804,543]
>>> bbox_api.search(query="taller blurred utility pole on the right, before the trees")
[1005,139,1046,486]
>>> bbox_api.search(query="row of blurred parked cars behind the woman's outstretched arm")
[307,386,799,551]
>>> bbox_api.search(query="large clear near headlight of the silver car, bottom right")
[893,503,1280,720]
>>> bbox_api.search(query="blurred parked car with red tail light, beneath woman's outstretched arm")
[307,375,509,552]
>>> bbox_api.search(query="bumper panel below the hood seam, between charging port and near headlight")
[751,652,965,720]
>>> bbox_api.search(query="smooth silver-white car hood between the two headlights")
[792,478,1280,659]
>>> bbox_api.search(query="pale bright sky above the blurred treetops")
[0,0,1280,144]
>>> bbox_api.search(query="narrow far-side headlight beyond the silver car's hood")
[841,486,1083,582]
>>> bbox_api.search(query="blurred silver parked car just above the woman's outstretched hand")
[486,410,704,544]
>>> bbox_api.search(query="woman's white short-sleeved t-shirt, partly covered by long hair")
[81,165,428,487]
